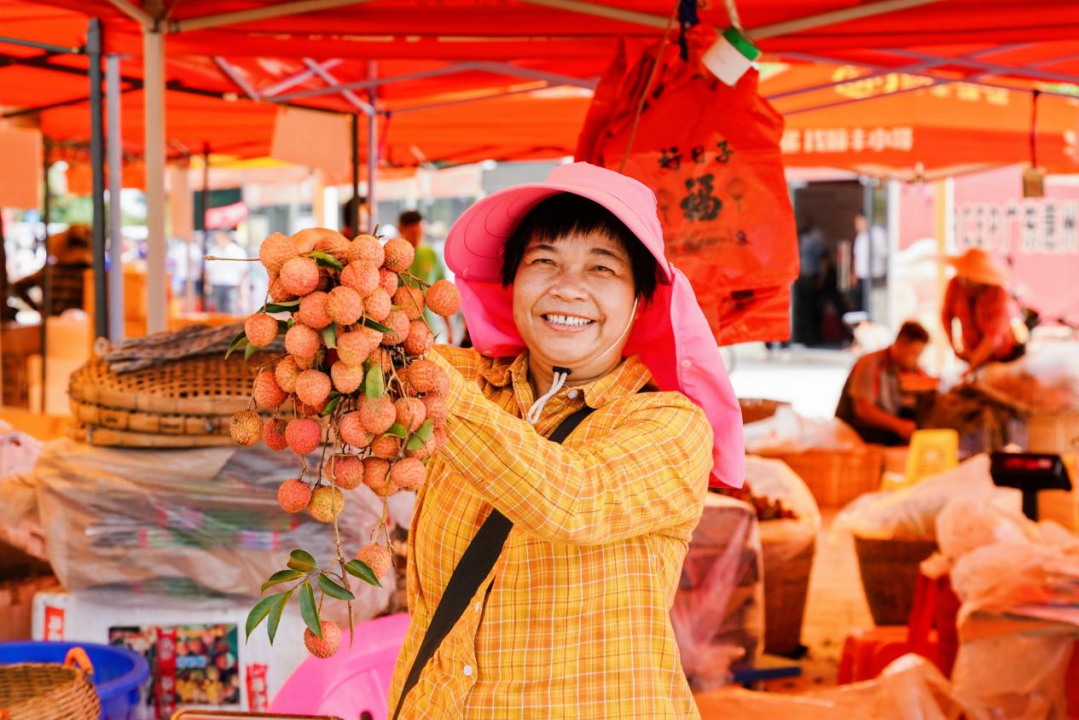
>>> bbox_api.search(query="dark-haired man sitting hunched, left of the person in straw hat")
[835,322,934,446]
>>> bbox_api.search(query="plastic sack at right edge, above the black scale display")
[973,342,1079,415]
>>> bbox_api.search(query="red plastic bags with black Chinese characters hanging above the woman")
[577,26,798,344]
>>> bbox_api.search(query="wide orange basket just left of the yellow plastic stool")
[760,445,884,507]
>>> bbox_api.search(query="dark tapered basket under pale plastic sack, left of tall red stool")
[855,536,937,625]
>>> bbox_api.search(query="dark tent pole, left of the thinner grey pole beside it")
[88,17,109,341]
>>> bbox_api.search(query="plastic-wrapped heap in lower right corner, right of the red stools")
[925,498,1079,720]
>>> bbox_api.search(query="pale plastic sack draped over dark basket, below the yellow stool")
[833,454,1022,540]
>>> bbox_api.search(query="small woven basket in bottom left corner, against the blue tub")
[0,664,101,720]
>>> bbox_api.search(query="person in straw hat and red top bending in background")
[942,247,1025,373]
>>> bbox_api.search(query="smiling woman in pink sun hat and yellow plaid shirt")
[390,163,745,718]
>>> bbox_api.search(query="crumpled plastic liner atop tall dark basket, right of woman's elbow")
[746,456,820,562]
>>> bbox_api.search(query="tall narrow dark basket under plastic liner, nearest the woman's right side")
[762,541,817,656]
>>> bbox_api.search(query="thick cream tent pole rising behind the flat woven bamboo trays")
[142,27,168,334]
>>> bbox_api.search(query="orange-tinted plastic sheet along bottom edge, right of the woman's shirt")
[697,655,962,720]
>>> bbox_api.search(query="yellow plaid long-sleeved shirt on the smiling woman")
[390,348,712,720]
